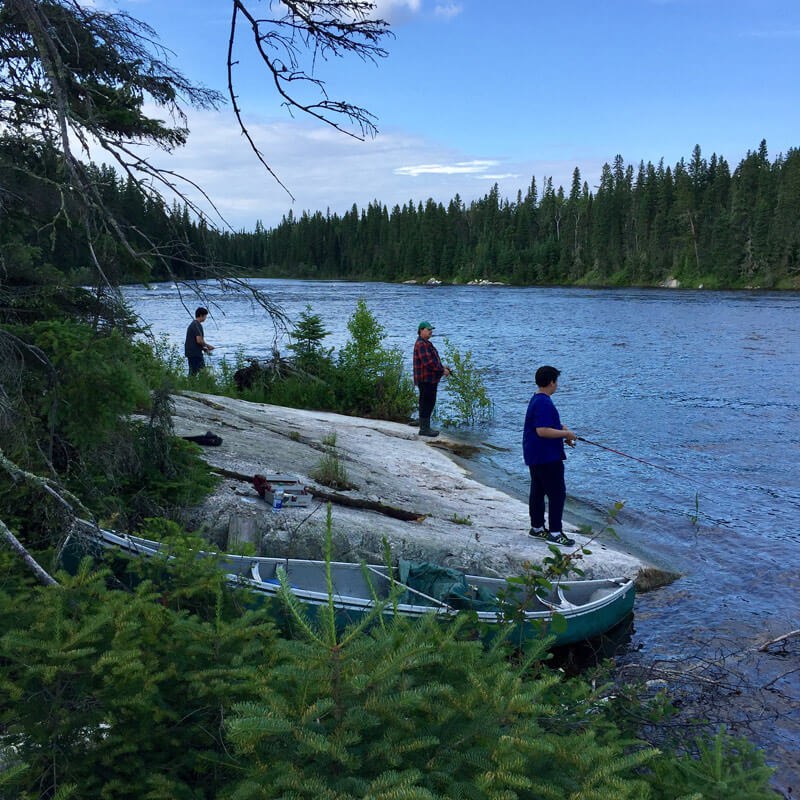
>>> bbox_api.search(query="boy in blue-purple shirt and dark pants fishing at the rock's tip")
[522,366,576,546]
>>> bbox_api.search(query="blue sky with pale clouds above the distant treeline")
[104,0,800,230]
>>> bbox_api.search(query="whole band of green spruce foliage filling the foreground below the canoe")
[0,519,772,800]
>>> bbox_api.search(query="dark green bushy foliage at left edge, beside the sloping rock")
[0,319,219,549]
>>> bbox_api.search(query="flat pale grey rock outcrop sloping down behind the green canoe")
[173,392,647,578]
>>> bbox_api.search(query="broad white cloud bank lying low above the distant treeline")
[101,106,602,230]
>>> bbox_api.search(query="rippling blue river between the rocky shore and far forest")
[125,280,800,786]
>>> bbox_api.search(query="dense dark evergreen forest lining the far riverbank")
[7,141,800,289]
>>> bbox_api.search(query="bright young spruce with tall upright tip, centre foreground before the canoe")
[227,517,657,800]
